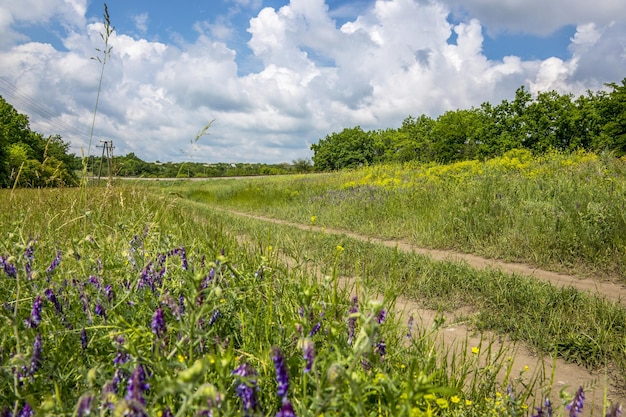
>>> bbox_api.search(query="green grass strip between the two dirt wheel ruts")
[168,197,626,391]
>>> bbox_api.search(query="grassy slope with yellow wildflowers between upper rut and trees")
[165,150,626,283]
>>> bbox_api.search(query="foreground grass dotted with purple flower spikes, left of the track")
[0,186,572,416]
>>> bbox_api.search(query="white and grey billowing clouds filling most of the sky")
[0,0,626,162]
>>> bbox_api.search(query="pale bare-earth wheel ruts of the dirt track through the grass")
[217,210,626,416]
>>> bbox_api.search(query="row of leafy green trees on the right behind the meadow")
[311,78,626,171]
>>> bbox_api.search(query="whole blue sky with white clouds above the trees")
[0,0,626,164]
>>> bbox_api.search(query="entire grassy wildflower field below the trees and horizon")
[0,152,626,416]
